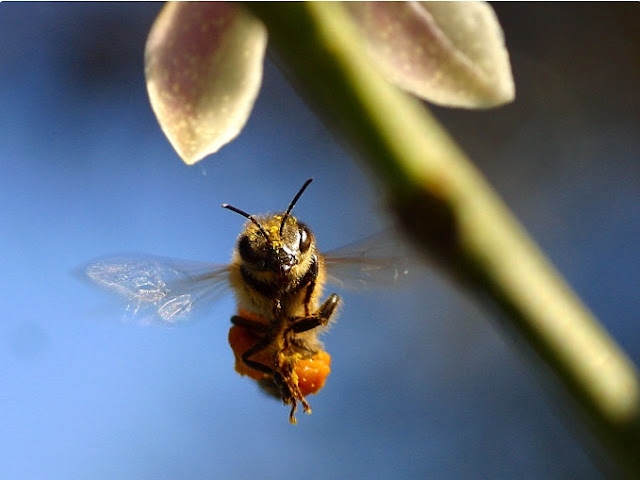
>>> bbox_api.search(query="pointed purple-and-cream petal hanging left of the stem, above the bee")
[145,2,267,165]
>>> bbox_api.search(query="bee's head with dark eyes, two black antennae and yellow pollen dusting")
[222,179,315,284]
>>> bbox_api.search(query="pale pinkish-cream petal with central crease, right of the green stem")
[346,2,515,108]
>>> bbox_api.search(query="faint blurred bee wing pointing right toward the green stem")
[324,230,410,289]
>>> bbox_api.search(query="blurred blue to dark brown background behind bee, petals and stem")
[0,3,640,480]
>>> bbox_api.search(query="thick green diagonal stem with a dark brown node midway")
[248,2,640,478]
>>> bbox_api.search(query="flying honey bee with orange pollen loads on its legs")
[85,178,408,424]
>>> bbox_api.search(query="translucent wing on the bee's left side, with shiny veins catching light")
[84,255,229,325]
